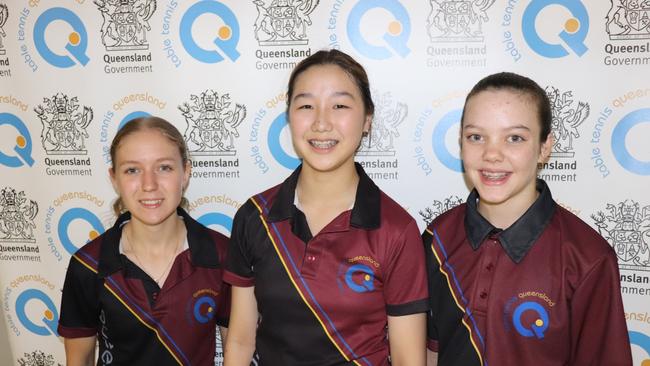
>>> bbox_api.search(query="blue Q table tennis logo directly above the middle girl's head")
[327,0,411,60]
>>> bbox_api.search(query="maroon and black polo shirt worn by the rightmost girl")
[423,180,632,366]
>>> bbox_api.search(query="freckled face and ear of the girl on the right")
[461,89,552,217]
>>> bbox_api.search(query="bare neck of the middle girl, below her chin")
[296,162,359,207]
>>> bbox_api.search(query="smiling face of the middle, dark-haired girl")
[289,65,372,172]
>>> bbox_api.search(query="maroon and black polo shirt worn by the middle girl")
[224,165,428,366]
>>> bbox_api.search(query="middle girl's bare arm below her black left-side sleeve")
[224,286,258,366]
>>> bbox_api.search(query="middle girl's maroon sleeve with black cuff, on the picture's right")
[384,220,429,316]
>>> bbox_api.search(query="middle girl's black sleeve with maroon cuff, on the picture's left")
[224,200,256,287]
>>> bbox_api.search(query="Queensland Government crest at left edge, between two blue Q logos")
[0,187,41,262]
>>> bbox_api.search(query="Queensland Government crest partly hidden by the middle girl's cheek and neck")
[355,92,408,180]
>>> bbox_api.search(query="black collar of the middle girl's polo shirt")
[268,163,381,229]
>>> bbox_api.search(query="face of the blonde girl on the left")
[109,129,190,226]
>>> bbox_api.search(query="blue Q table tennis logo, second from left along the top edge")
[160,0,240,68]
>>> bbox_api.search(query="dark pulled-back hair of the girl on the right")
[461,72,553,142]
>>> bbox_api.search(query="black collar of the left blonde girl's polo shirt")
[99,208,220,277]
